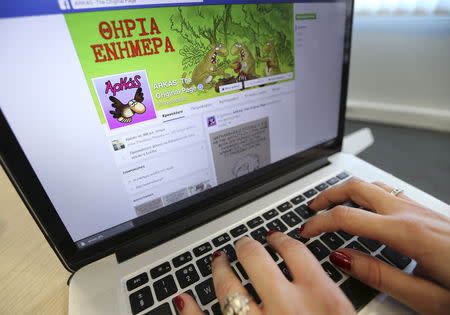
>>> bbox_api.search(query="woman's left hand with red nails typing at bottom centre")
[174,231,355,315]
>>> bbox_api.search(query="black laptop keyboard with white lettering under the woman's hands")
[125,172,412,315]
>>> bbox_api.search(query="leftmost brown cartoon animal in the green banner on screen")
[182,44,228,89]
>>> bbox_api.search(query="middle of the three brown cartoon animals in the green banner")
[230,43,256,81]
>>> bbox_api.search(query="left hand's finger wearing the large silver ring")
[212,252,261,315]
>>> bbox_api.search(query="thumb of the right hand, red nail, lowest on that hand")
[330,249,450,314]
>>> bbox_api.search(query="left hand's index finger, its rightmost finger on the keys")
[267,231,331,284]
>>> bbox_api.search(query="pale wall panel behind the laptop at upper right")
[347,16,450,131]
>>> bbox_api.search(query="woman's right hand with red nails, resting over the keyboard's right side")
[301,179,450,314]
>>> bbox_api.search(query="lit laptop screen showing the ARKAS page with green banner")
[0,0,347,248]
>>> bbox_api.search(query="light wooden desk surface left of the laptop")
[0,167,69,314]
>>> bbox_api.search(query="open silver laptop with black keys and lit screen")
[0,0,449,315]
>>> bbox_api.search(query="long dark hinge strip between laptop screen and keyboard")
[116,157,330,263]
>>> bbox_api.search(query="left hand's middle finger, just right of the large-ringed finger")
[236,237,292,313]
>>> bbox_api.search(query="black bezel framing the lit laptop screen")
[0,0,353,272]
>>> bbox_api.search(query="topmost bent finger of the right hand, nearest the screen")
[309,178,401,214]
